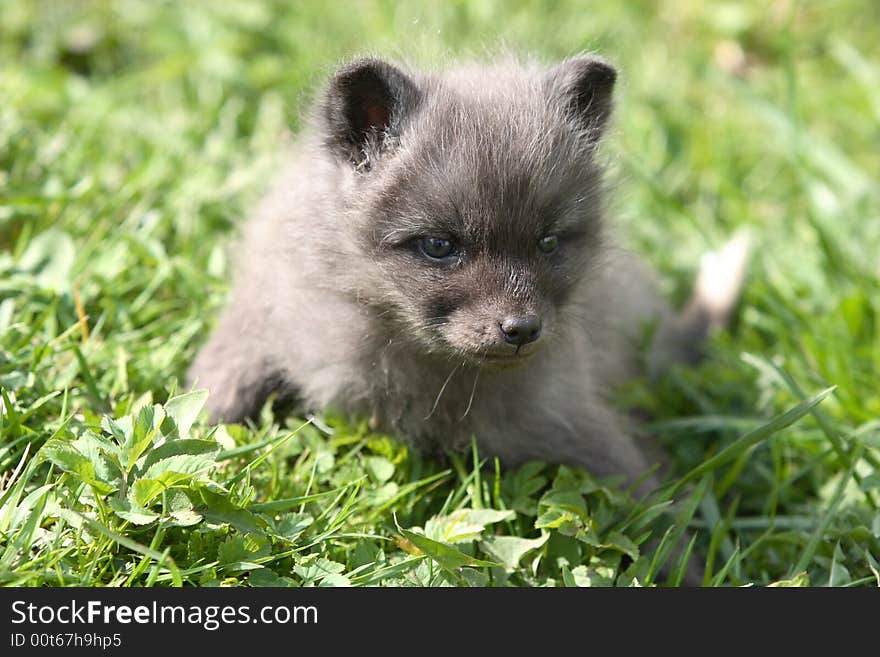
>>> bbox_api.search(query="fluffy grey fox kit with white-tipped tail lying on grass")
[189,55,745,490]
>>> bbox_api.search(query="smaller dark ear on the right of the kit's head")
[546,55,617,140]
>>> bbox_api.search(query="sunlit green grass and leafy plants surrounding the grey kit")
[0,0,880,586]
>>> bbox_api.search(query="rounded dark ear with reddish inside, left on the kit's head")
[322,59,420,164]
